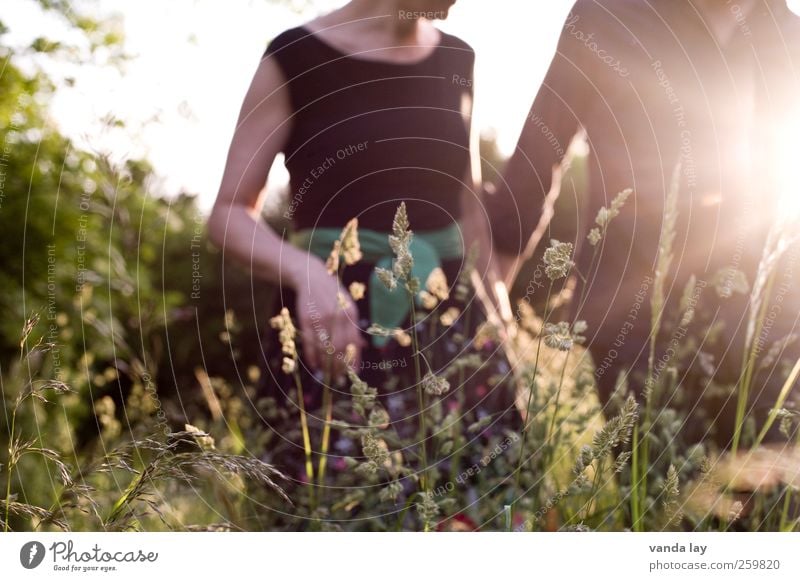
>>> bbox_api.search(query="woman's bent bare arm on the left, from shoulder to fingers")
[208,57,363,373]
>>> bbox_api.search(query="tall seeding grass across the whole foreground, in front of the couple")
[0,187,800,531]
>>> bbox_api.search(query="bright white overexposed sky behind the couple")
[0,0,572,210]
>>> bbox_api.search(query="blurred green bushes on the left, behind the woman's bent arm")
[0,2,284,529]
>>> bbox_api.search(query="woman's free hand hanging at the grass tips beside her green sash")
[291,255,365,378]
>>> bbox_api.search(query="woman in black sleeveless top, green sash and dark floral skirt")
[209,0,517,524]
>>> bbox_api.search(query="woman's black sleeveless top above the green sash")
[265,27,474,231]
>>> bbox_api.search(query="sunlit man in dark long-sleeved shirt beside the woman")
[488,0,800,443]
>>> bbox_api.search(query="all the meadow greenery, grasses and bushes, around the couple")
[0,2,800,531]
